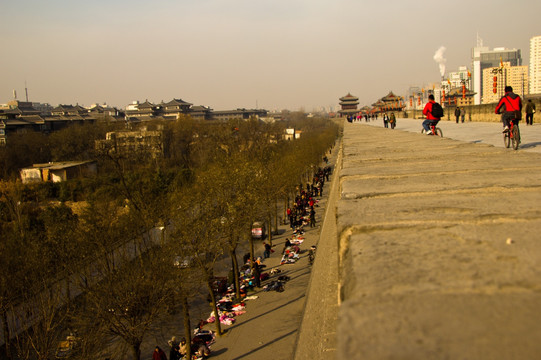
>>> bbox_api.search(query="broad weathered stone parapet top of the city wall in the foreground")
[322,122,541,359]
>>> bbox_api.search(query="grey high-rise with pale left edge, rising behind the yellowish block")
[472,39,522,105]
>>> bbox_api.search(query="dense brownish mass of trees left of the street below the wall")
[0,115,338,360]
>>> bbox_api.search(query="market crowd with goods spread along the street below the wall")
[152,157,331,360]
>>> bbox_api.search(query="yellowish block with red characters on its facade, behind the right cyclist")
[481,62,528,104]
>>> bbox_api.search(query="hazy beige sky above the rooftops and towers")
[0,0,541,111]
